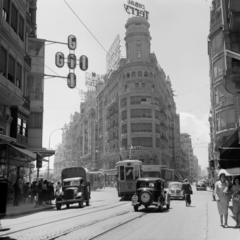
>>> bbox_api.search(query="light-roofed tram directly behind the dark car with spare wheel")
[116,160,142,199]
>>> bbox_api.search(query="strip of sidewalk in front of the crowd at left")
[5,202,55,218]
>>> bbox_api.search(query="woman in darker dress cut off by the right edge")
[230,177,240,227]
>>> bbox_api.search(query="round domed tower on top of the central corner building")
[124,17,152,63]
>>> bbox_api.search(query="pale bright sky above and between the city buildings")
[37,0,211,169]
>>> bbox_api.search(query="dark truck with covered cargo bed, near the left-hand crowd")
[56,167,91,210]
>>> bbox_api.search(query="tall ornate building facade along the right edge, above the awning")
[208,0,240,178]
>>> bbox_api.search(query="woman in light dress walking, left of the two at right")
[214,173,230,227]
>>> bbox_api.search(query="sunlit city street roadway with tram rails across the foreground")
[0,188,240,240]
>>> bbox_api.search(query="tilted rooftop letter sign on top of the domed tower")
[123,0,149,20]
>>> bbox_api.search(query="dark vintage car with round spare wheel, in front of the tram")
[132,177,170,212]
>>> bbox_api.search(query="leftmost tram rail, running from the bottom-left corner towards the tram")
[0,202,129,239]
